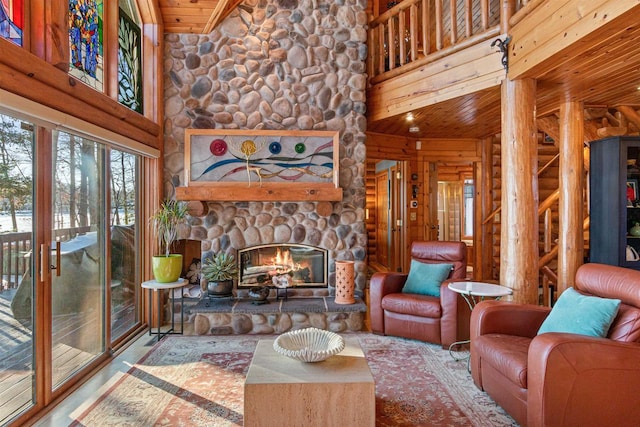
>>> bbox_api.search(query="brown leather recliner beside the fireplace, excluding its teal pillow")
[369,241,471,347]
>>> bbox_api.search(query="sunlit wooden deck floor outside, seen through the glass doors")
[0,289,135,425]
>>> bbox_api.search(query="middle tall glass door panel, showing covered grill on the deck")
[50,131,106,389]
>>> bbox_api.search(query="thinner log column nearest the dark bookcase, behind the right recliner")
[557,102,585,295]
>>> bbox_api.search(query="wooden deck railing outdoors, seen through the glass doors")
[0,227,91,292]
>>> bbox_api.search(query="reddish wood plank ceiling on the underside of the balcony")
[367,10,640,138]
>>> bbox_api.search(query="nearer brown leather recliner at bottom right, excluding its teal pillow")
[471,263,640,427]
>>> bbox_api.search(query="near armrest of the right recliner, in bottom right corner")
[527,333,640,426]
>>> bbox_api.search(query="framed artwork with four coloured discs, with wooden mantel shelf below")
[176,129,342,201]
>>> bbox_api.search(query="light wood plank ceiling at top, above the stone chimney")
[158,0,242,34]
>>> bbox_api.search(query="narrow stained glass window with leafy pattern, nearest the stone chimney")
[118,0,142,113]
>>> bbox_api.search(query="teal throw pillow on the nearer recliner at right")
[538,288,620,337]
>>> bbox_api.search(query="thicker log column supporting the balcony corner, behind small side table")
[500,79,539,304]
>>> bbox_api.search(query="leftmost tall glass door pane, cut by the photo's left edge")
[0,114,35,425]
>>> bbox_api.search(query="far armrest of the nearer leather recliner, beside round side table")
[471,300,551,340]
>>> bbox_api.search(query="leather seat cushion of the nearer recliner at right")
[474,334,531,388]
